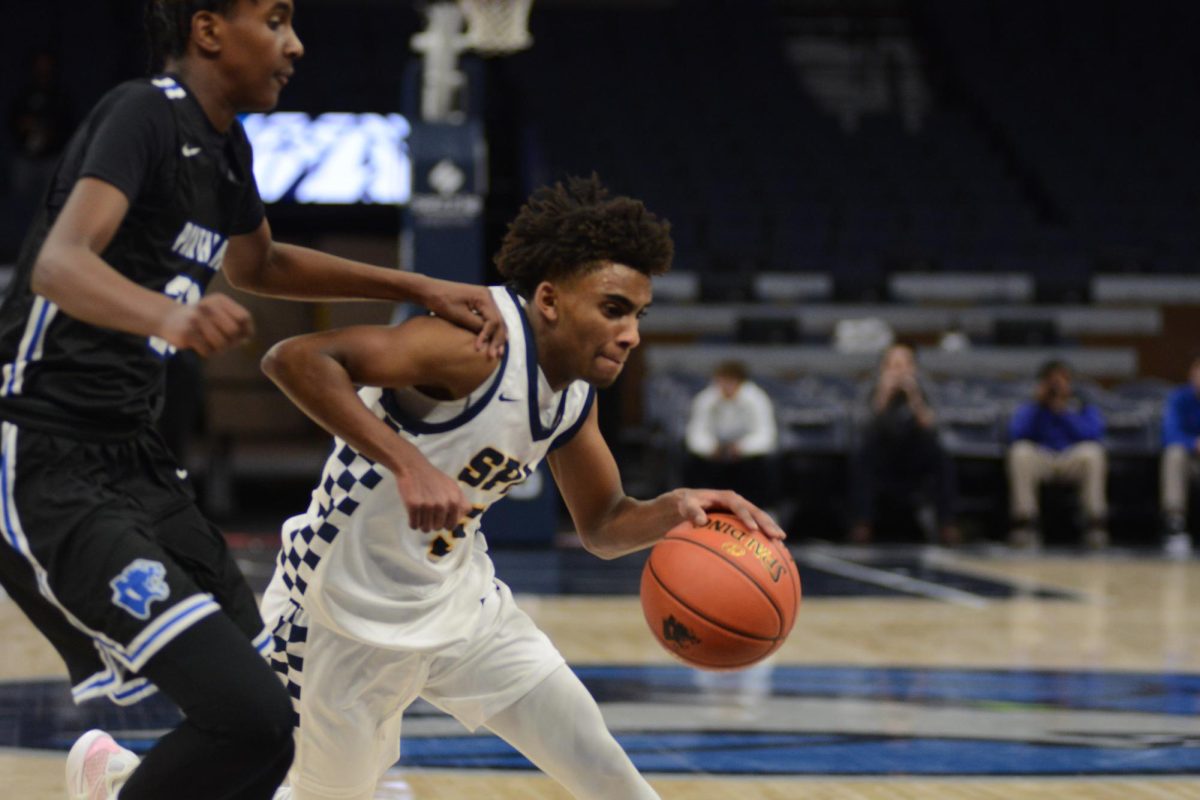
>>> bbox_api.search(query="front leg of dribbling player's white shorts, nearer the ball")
[421,582,565,730]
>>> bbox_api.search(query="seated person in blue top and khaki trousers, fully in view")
[1008,360,1109,548]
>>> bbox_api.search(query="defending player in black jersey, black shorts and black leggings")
[0,0,504,800]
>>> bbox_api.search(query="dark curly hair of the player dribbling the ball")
[494,173,674,297]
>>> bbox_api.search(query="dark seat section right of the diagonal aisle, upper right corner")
[919,0,1200,278]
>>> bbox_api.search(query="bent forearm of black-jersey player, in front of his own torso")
[30,242,174,336]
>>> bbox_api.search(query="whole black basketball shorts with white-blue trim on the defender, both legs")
[0,422,270,704]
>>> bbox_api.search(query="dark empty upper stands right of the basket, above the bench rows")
[515,0,1200,297]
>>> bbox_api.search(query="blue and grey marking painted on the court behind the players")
[9,666,1200,776]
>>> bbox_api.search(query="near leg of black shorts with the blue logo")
[0,423,215,669]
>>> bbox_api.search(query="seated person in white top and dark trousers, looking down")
[684,361,779,507]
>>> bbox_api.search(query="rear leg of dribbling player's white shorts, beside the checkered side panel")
[285,619,427,798]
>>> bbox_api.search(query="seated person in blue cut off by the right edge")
[1159,355,1200,555]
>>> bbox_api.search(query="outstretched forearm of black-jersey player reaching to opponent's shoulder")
[229,242,430,303]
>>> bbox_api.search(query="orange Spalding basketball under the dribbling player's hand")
[642,513,800,669]
